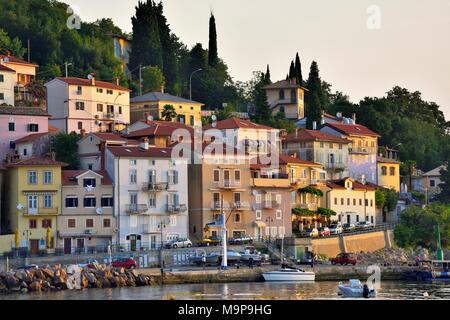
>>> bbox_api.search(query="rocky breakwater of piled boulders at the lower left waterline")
[0,265,155,294]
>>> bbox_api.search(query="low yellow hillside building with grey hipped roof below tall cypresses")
[130,92,203,126]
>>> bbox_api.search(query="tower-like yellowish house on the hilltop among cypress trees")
[264,79,307,120]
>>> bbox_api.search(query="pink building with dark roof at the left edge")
[0,106,50,162]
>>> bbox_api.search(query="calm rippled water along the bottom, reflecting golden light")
[0,281,450,300]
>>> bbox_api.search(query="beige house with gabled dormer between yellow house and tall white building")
[57,170,117,254]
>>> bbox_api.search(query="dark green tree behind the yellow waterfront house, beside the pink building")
[52,133,80,170]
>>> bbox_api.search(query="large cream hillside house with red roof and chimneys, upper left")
[45,75,130,133]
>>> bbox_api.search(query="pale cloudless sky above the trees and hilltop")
[63,0,450,120]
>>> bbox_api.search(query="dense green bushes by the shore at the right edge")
[394,204,450,249]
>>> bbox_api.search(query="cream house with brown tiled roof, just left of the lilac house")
[282,129,351,179]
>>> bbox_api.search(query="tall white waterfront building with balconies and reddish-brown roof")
[105,142,189,250]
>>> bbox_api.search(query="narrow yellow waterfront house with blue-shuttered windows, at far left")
[5,157,66,254]
